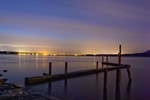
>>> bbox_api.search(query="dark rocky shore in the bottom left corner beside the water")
[0,83,60,100]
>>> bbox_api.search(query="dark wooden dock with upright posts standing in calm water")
[25,46,131,86]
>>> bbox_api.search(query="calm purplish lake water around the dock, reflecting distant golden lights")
[0,55,150,100]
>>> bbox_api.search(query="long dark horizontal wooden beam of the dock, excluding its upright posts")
[25,65,127,85]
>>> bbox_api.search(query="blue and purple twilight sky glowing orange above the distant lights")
[0,0,150,53]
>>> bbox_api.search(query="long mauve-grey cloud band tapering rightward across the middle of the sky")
[0,14,138,37]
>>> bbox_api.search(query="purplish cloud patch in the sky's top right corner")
[79,0,150,21]
